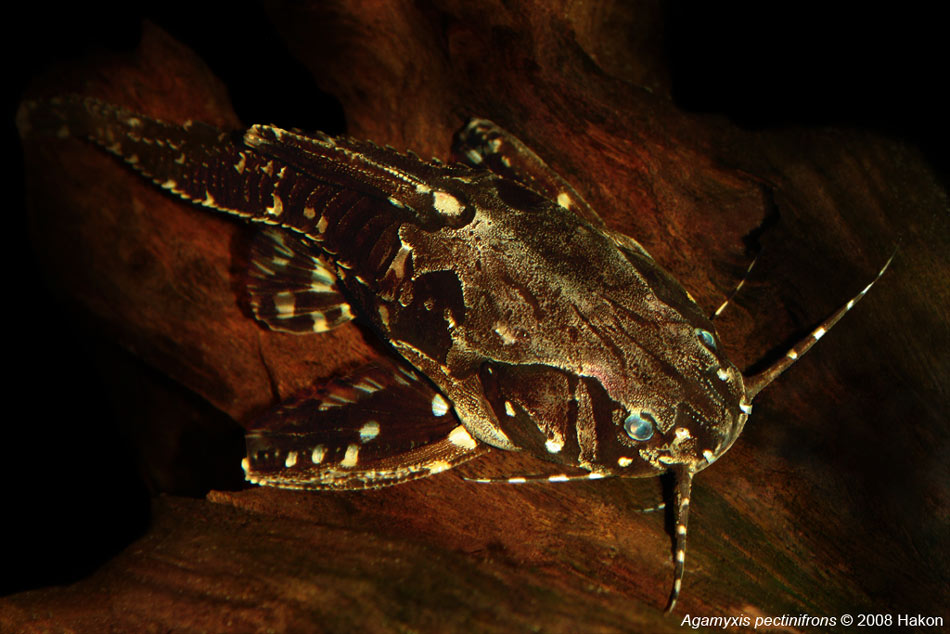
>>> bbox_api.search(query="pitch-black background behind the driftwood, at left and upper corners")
[0,2,950,594]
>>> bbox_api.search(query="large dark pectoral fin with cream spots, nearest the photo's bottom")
[244,361,488,489]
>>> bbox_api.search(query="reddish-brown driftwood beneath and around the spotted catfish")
[7,2,950,632]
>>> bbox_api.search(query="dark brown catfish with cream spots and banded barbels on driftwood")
[19,97,886,609]
